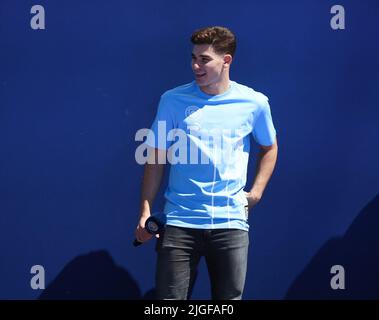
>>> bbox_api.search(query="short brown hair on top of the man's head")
[191,26,237,57]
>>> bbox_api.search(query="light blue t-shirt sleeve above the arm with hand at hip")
[252,99,276,146]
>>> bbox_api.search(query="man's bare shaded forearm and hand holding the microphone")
[136,149,166,242]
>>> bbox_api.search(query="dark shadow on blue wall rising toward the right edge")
[285,194,379,299]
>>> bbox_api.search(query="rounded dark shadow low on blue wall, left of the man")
[38,250,141,300]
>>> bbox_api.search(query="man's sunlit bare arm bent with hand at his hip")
[246,139,278,209]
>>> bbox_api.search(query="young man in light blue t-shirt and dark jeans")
[136,27,278,299]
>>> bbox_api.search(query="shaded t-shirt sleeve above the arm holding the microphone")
[145,95,174,150]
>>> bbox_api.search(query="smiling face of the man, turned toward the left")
[191,44,231,87]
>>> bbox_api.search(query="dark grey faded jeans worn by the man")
[156,226,249,300]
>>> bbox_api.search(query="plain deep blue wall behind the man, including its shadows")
[0,0,379,299]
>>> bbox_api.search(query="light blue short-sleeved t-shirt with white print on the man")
[145,81,276,230]
